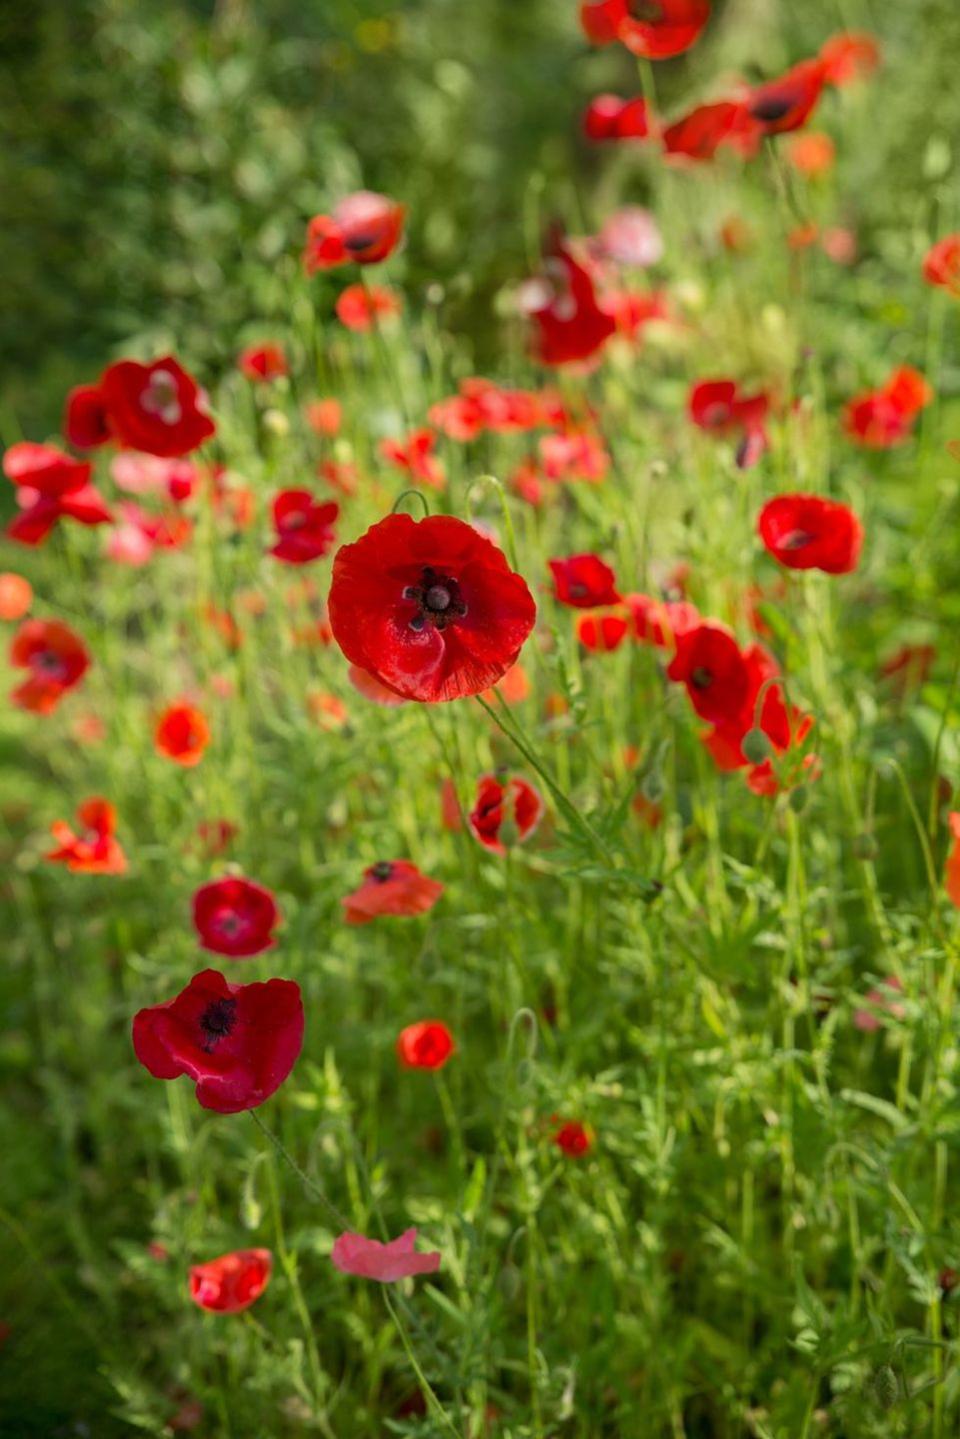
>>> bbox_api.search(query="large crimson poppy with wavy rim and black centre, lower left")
[132,970,304,1114]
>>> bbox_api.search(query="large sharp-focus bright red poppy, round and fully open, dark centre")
[328,514,537,704]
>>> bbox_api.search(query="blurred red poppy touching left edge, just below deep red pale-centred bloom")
[3,440,112,545]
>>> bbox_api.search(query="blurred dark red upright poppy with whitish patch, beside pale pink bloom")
[522,243,616,366]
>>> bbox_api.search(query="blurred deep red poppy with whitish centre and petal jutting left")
[63,355,216,458]
